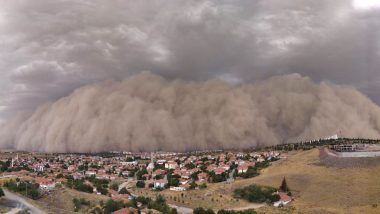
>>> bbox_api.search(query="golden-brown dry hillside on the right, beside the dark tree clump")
[254,149,380,213]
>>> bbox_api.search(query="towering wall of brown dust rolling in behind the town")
[0,72,380,152]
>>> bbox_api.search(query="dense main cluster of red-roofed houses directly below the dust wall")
[1,151,282,209]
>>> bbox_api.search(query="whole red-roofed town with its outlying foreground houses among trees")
[0,150,291,213]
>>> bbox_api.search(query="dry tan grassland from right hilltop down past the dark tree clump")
[131,149,380,214]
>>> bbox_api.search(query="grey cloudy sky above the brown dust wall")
[0,0,380,120]
